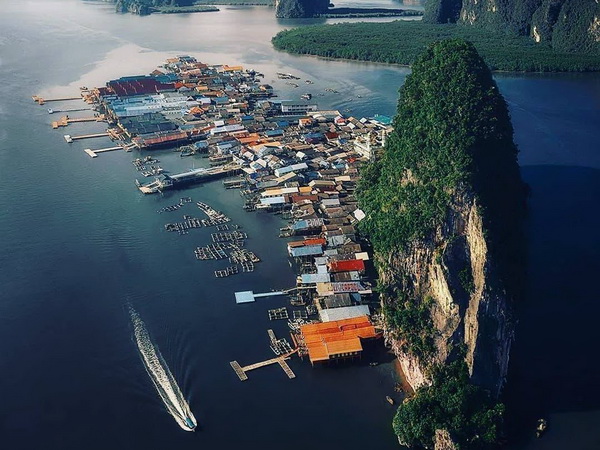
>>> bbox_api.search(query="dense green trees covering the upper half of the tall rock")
[358,40,522,251]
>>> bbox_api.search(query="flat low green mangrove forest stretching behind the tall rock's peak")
[273,21,600,72]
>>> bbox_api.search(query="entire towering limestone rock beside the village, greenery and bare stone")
[357,40,526,448]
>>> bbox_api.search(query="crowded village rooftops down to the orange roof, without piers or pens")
[92,56,391,362]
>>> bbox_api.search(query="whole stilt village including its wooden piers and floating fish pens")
[33,56,393,394]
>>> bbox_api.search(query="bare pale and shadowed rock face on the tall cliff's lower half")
[379,186,513,395]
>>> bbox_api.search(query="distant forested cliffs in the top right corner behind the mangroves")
[424,0,600,53]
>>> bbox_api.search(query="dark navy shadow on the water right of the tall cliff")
[505,166,600,442]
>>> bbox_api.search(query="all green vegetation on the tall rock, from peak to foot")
[357,40,525,449]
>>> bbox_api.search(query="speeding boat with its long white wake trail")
[129,305,197,431]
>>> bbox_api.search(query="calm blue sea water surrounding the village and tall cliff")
[0,0,600,449]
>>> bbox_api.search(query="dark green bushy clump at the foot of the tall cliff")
[393,360,504,450]
